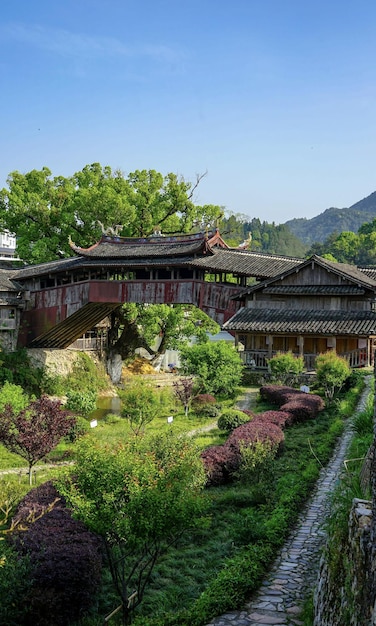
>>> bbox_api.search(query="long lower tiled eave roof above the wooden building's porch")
[222,307,376,335]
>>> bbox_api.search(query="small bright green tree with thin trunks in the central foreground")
[59,432,205,624]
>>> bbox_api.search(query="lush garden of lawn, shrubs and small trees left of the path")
[0,345,372,626]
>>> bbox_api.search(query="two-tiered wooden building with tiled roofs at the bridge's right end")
[223,255,376,370]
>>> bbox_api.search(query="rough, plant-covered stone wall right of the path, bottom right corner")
[314,498,375,626]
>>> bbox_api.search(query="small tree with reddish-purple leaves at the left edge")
[0,396,75,485]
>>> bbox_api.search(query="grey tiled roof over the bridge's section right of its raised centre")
[190,249,302,278]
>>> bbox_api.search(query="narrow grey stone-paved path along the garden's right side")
[207,377,371,626]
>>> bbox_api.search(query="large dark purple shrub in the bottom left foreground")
[12,482,102,626]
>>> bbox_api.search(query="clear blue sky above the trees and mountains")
[0,0,376,224]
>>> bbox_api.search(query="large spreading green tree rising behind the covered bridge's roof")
[0,163,222,263]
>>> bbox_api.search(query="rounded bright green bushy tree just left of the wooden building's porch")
[180,341,243,397]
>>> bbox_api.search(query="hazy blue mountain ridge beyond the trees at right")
[285,191,376,245]
